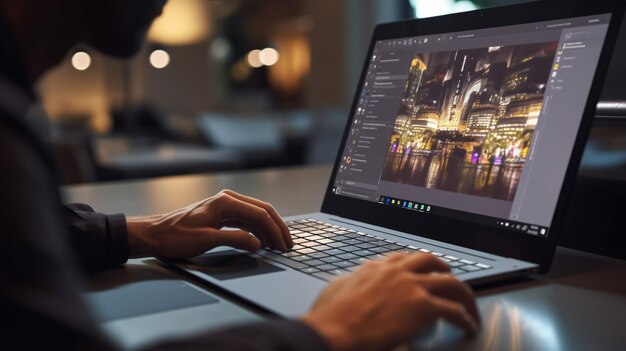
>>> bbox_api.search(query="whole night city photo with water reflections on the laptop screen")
[382,42,560,201]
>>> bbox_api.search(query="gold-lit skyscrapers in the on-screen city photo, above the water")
[391,43,555,160]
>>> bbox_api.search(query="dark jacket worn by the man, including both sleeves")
[0,17,326,351]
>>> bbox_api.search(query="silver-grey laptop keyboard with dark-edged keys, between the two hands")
[257,219,491,281]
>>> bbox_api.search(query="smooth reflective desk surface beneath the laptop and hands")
[63,166,626,350]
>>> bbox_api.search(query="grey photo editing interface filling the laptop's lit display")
[333,14,610,237]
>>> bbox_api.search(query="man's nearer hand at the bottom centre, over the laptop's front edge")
[302,254,480,350]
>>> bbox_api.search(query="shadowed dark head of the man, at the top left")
[0,0,167,81]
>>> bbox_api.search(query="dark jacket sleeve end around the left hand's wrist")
[63,204,128,272]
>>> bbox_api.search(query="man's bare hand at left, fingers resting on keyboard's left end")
[127,190,294,258]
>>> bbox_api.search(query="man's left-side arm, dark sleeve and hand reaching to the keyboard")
[64,190,294,272]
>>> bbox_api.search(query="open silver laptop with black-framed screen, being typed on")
[169,1,624,317]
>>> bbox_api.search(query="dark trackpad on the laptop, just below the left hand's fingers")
[184,250,284,280]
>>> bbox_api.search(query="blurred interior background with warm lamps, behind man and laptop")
[38,0,626,184]
